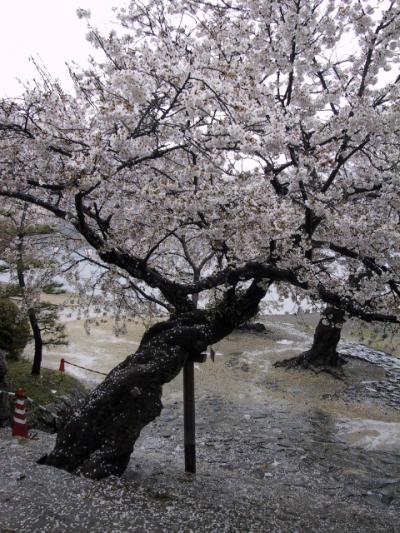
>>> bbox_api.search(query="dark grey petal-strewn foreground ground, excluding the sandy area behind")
[0,395,400,533]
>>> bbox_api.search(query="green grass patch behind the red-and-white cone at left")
[7,359,84,405]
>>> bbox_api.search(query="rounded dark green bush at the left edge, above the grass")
[0,298,30,359]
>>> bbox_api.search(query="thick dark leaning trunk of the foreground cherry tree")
[39,282,266,479]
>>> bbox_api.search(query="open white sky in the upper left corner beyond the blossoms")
[0,0,117,97]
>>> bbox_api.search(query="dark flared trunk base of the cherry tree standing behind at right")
[275,306,345,372]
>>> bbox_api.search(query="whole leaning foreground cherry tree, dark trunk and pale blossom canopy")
[0,0,400,478]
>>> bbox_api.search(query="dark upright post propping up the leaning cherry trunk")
[183,359,196,474]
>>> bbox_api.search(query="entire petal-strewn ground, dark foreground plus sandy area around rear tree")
[0,317,400,533]
